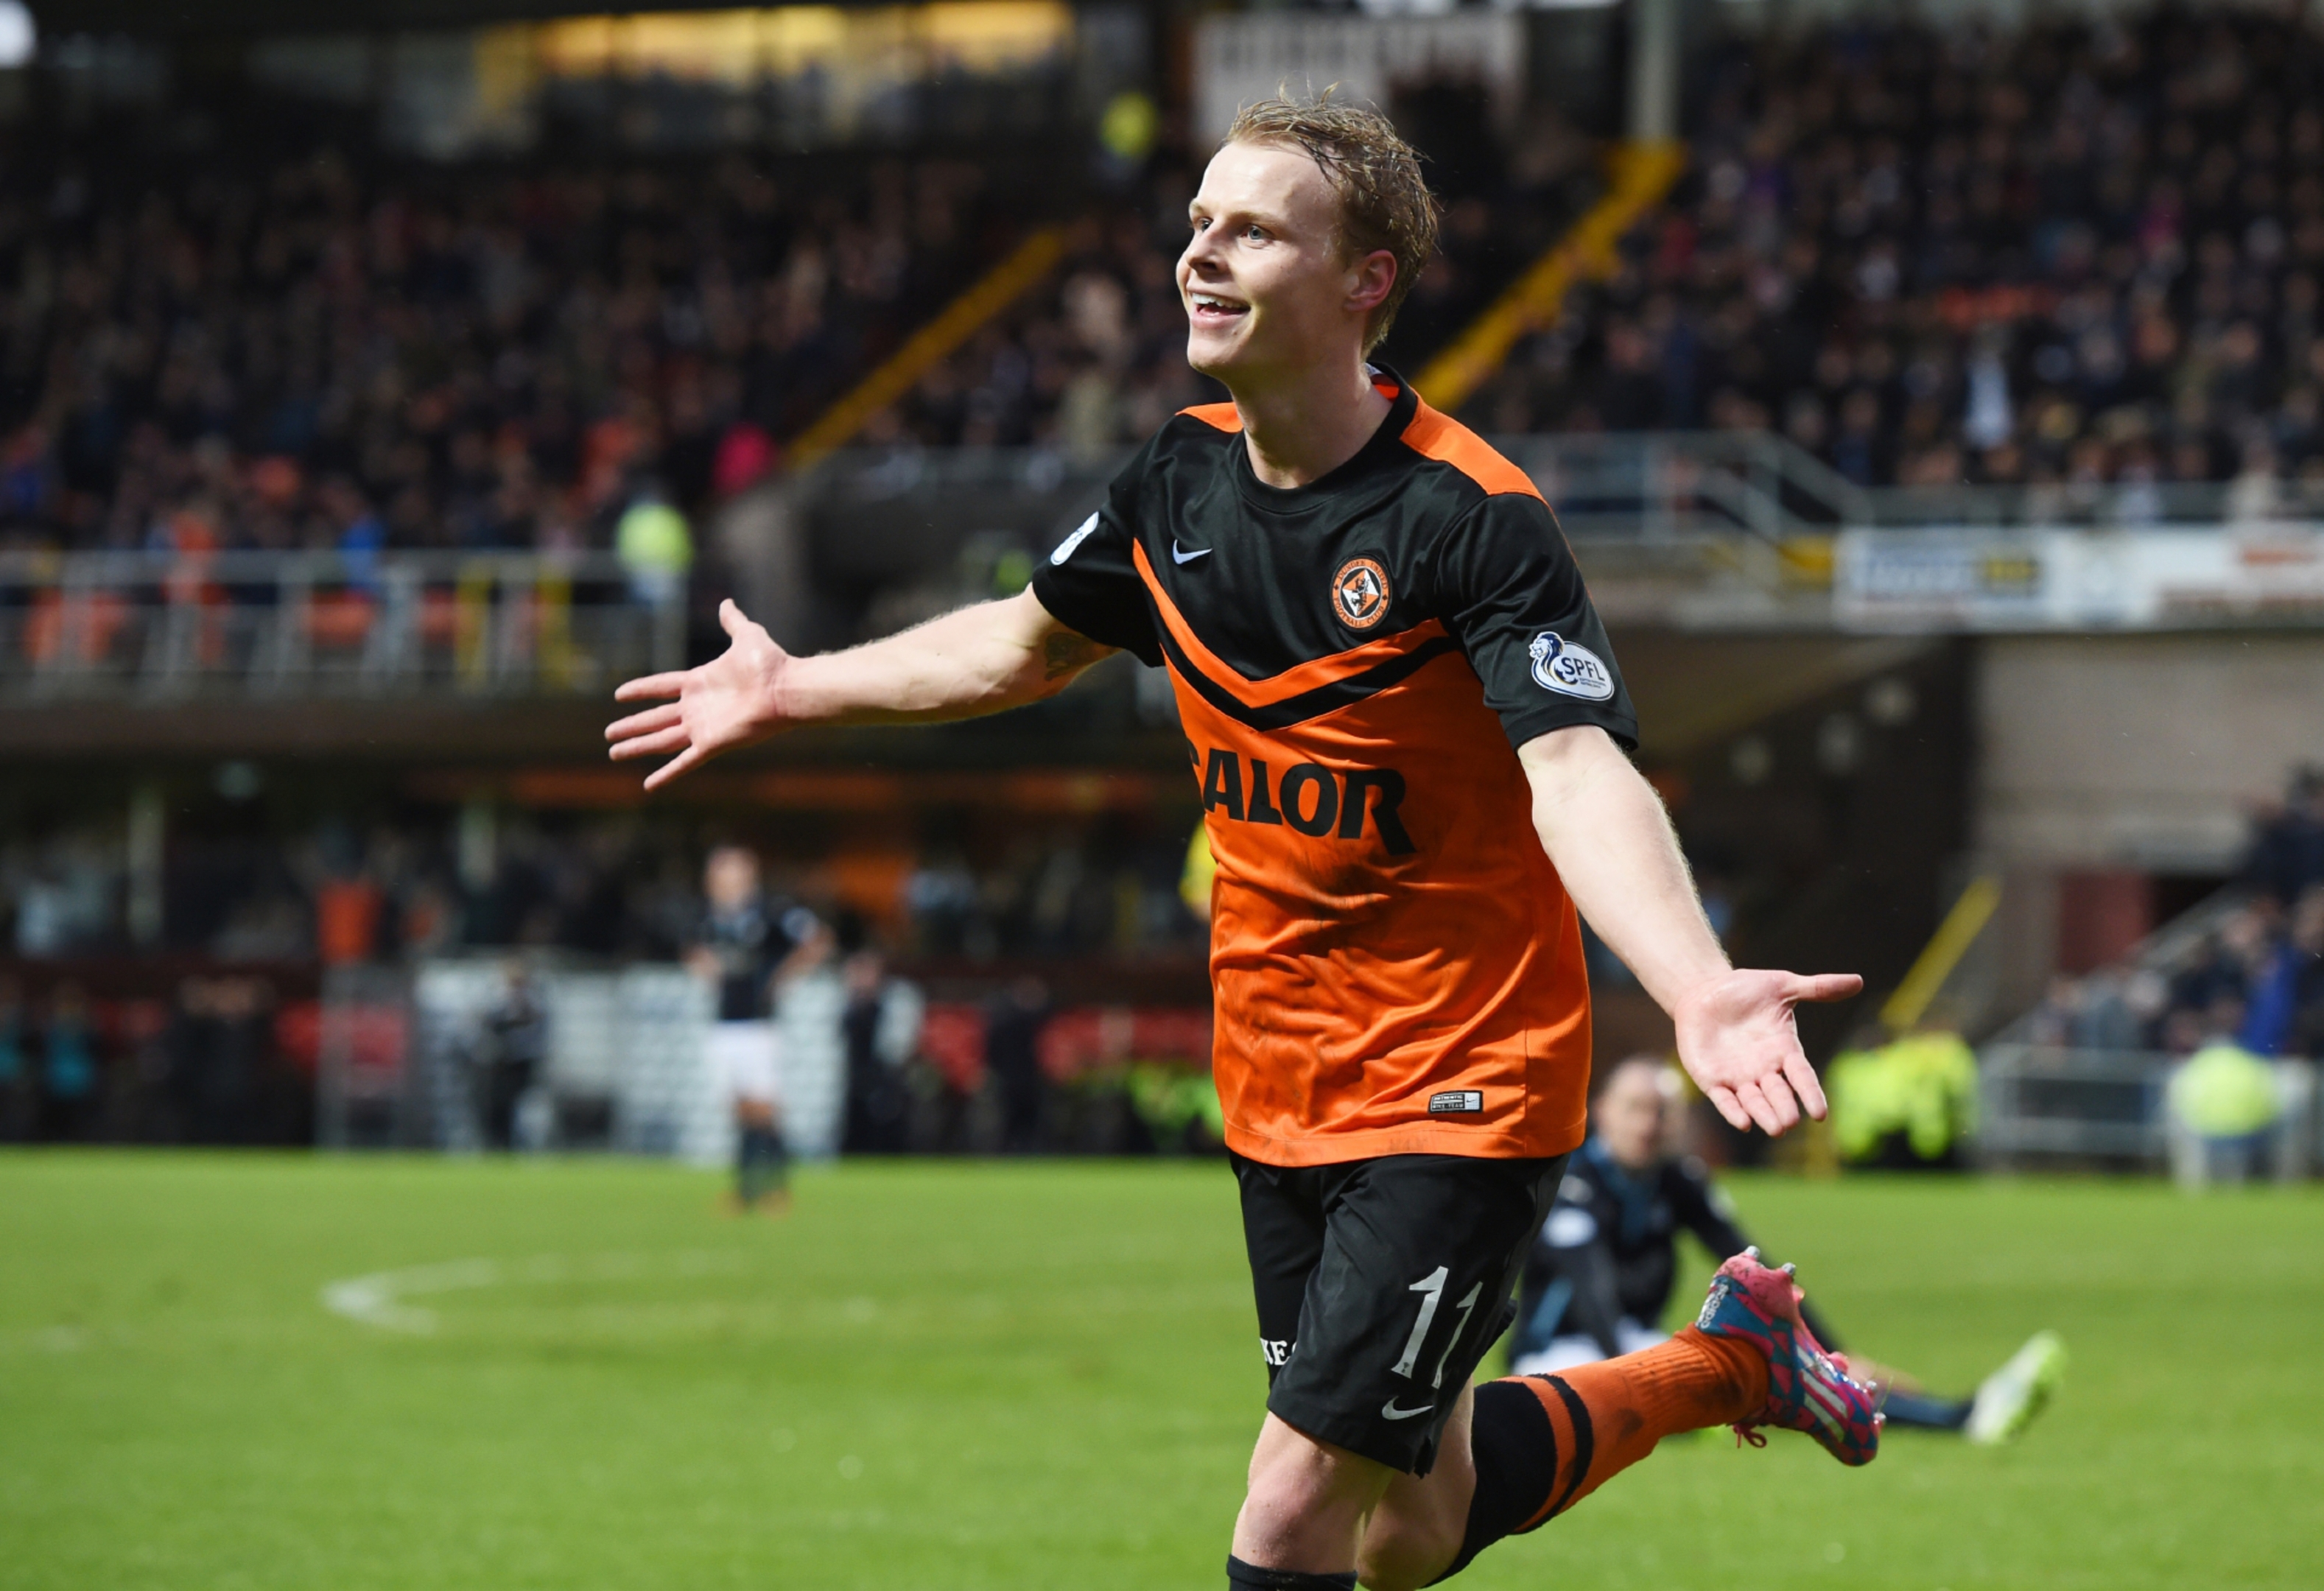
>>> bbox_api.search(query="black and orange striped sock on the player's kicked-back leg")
[1436,1327,1766,1581]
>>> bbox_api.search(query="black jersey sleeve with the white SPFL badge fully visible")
[1436,492,1638,748]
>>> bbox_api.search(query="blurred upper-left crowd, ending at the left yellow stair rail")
[0,87,1064,552]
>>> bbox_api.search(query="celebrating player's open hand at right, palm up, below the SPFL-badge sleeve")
[1671,969,1864,1138]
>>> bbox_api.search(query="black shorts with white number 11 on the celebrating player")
[1232,1154,1566,1475]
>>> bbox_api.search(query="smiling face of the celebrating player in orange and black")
[1179,144,1397,388]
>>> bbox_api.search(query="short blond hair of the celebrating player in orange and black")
[1220,88,1439,353]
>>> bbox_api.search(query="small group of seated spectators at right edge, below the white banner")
[2034,769,2324,1061]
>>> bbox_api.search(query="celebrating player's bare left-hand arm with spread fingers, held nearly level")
[604,590,1115,790]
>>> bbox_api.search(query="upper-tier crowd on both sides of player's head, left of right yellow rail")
[0,68,1596,555]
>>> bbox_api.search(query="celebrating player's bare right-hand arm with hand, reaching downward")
[1517,725,1864,1136]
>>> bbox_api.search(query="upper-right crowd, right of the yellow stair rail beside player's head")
[1469,7,2324,502]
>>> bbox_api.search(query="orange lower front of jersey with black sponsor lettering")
[1171,613,1590,1166]
